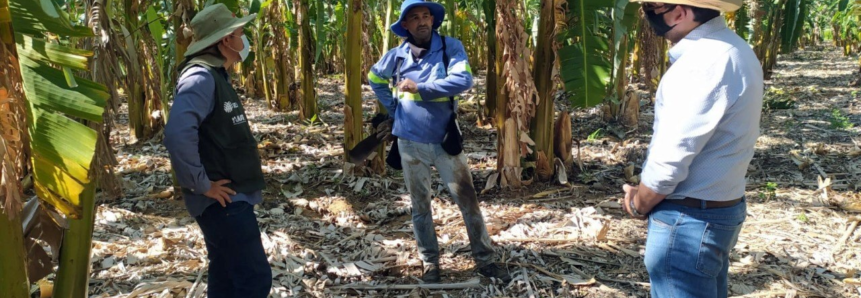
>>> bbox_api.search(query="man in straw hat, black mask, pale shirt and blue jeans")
[622,0,763,297]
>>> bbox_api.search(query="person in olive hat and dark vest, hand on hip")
[164,4,272,298]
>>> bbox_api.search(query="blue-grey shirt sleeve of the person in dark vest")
[164,67,215,194]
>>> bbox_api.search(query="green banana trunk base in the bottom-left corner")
[0,206,30,298]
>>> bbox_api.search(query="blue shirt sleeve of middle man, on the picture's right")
[417,38,472,99]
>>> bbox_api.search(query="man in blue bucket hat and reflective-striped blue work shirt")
[368,0,511,283]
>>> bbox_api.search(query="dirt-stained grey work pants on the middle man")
[398,139,495,268]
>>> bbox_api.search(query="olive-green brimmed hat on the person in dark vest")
[185,3,257,57]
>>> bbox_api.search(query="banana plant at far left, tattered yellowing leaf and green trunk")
[0,0,110,298]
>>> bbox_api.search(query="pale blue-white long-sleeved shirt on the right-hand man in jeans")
[641,16,763,201]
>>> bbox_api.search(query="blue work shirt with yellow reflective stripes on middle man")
[368,31,472,144]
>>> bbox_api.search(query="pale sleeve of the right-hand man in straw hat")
[641,58,739,195]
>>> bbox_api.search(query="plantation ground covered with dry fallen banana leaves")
[75,48,861,297]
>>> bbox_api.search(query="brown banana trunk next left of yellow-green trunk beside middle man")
[294,0,320,120]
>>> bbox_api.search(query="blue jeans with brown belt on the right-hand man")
[645,199,747,298]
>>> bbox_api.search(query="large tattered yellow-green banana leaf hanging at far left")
[9,0,110,218]
